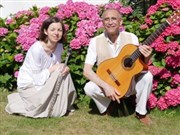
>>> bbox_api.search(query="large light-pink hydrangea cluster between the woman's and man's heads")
[56,0,101,49]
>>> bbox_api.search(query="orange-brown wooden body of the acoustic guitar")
[97,44,145,98]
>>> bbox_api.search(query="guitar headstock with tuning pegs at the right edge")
[167,9,180,24]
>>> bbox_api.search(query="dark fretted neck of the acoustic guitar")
[130,21,169,61]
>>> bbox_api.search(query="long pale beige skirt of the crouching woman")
[5,71,77,118]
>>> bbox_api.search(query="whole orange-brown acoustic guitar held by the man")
[96,11,180,98]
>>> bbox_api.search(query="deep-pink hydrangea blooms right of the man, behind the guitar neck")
[140,0,180,110]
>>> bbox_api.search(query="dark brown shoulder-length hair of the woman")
[38,16,66,43]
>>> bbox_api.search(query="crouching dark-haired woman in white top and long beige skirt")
[5,17,76,118]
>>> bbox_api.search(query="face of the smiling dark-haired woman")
[44,22,63,43]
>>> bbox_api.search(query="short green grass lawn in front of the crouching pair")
[0,92,180,135]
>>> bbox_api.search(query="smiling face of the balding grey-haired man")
[102,10,122,35]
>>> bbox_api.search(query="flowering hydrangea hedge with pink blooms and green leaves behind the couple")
[0,0,180,110]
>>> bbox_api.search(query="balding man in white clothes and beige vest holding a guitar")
[83,9,153,124]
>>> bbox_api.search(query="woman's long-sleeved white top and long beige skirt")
[5,41,76,118]
